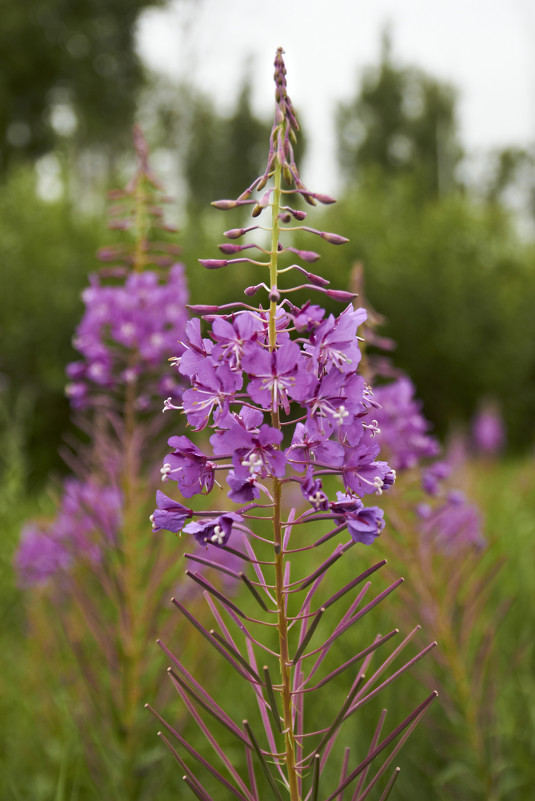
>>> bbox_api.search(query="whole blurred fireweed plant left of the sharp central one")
[16,129,193,798]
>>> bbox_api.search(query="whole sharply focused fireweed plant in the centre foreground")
[149,49,436,801]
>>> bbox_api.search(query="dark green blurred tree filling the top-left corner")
[0,0,165,172]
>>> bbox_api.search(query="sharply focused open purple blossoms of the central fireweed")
[153,302,395,545]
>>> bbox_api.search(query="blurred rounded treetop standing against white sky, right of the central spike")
[337,33,462,199]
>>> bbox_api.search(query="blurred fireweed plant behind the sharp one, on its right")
[354,282,510,799]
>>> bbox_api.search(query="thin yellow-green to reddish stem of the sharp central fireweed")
[269,158,300,801]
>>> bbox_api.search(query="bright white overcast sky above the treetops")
[138,0,535,191]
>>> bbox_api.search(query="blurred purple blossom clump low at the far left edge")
[15,478,122,587]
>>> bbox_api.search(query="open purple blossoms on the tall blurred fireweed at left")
[66,264,188,408]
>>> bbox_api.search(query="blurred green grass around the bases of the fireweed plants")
[0,460,535,801]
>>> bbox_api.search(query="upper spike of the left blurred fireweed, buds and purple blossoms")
[66,127,188,410]
